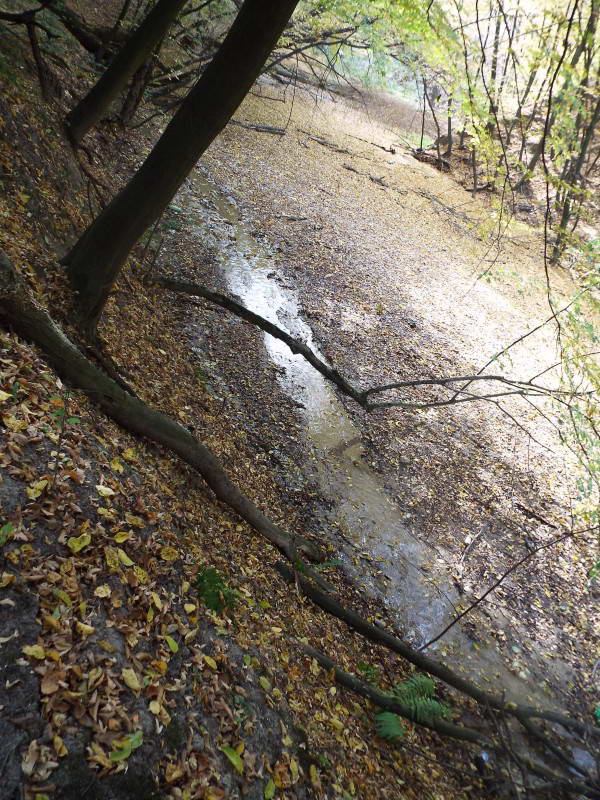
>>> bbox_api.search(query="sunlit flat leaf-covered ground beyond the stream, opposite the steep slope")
[183,78,599,713]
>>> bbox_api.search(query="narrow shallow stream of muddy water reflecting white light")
[186,172,568,706]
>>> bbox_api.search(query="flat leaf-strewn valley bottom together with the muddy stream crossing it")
[159,76,597,724]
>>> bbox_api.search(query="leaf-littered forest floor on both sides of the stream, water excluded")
[0,10,598,800]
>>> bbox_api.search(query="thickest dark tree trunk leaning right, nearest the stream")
[64,0,298,330]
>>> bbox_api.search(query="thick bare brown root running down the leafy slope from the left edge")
[0,250,324,564]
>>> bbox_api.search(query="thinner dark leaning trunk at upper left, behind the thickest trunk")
[66,0,187,144]
